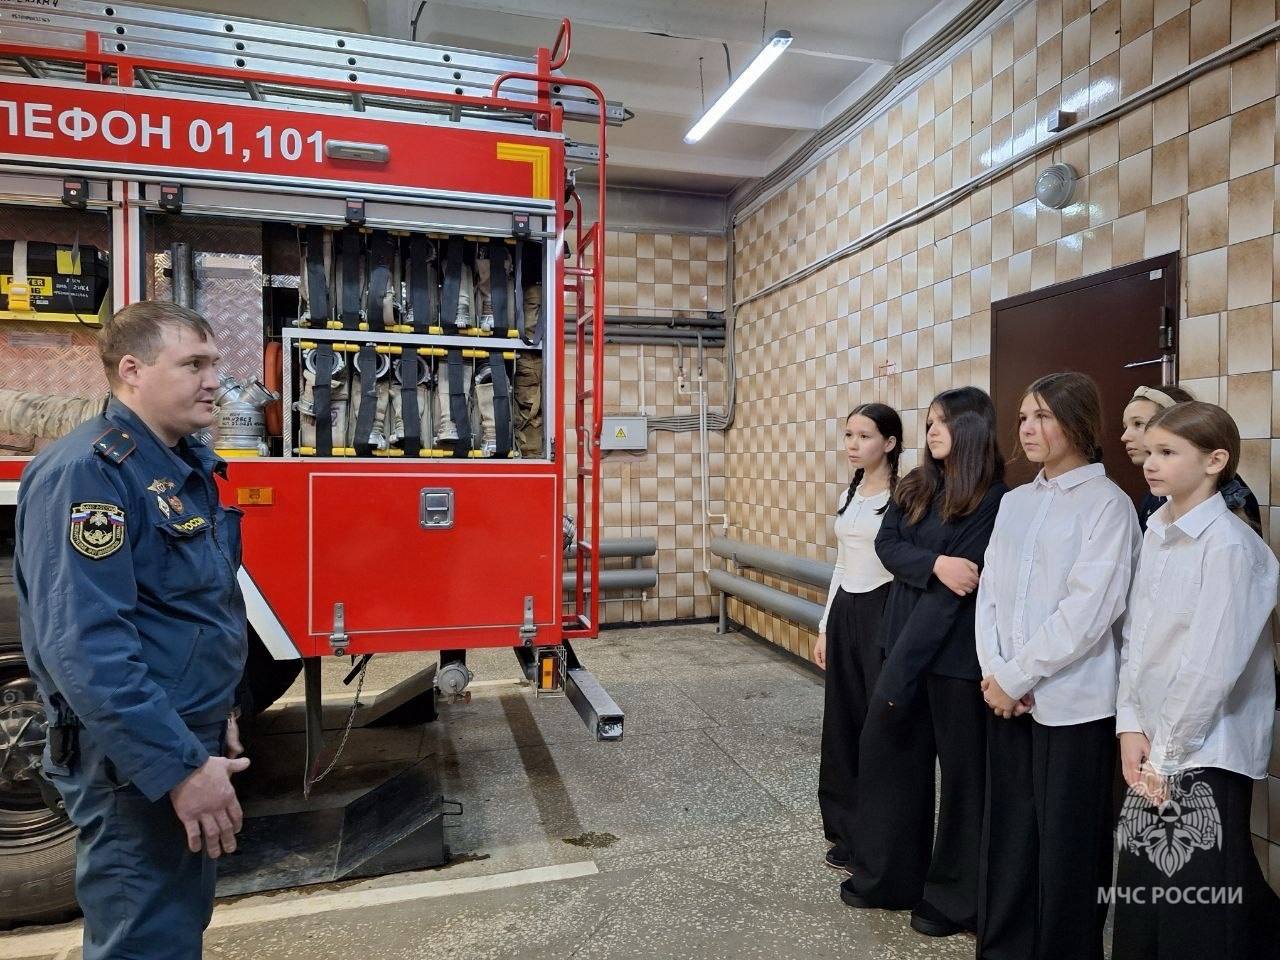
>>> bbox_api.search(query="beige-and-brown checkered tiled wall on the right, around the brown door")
[726,0,1280,882]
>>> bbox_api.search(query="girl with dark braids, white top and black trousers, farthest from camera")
[813,403,902,870]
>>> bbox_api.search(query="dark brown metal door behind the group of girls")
[991,253,1178,500]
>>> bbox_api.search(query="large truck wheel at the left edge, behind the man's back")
[0,650,78,929]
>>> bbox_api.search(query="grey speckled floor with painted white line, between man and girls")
[0,626,974,960]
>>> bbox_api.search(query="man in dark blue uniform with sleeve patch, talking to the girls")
[14,302,248,960]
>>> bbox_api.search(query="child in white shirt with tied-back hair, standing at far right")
[1114,401,1280,960]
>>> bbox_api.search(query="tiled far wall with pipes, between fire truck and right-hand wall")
[564,232,727,622]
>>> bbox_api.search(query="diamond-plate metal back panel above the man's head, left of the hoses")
[147,219,262,381]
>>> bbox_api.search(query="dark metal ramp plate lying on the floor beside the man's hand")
[218,756,449,896]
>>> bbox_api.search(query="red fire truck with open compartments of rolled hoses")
[0,0,625,922]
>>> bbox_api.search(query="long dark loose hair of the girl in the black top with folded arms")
[895,387,1005,524]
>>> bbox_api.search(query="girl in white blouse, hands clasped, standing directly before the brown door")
[975,372,1139,960]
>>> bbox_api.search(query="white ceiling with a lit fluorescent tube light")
[367,0,941,193]
